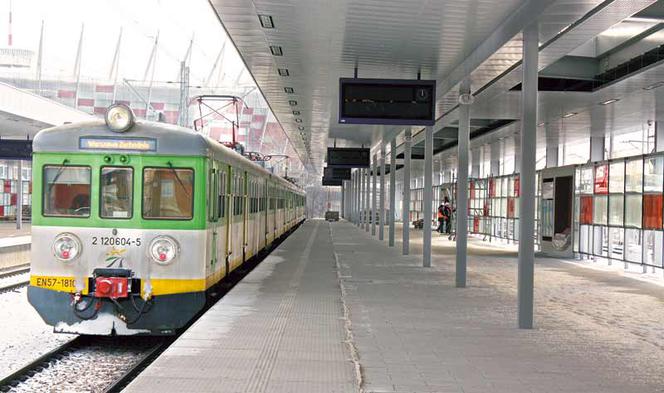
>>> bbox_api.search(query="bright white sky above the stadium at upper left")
[0,0,252,84]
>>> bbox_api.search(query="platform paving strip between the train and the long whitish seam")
[126,221,357,393]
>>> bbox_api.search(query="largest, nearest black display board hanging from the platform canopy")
[339,78,436,126]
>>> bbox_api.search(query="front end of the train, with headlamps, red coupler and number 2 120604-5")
[28,106,208,335]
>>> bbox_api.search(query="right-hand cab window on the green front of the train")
[143,168,194,220]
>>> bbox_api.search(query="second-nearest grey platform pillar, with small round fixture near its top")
[455,80,472,288]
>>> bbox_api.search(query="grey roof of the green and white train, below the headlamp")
[32,119,302,192]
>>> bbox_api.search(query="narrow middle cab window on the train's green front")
[100,167,134,218]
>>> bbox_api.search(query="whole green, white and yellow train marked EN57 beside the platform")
[27,104,306,335]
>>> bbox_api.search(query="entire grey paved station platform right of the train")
[126,220,664,393]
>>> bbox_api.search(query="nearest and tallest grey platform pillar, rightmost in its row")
[518,22,539,329]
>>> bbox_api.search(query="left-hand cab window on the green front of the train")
[42,165,91,217]
